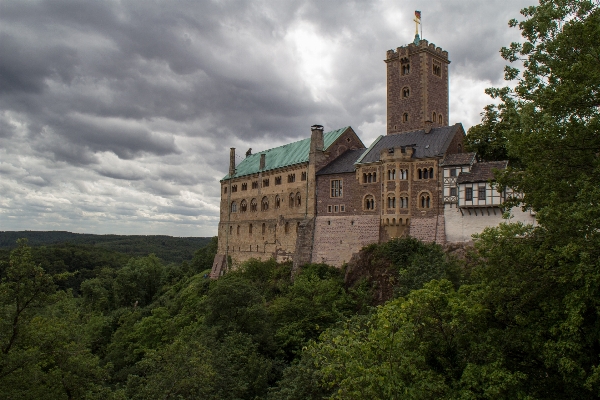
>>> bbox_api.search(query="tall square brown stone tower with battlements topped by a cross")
[385,35,450,135]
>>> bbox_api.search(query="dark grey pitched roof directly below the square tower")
[357,124,462,164]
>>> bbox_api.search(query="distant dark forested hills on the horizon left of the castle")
[0,231,211,264]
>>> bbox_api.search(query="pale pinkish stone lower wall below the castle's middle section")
[312,215,380,267]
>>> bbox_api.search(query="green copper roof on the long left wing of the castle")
[223,127,349,180]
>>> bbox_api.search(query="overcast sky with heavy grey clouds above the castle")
[0,0,533,236]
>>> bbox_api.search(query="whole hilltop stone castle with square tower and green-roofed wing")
[211,30,534,278]
